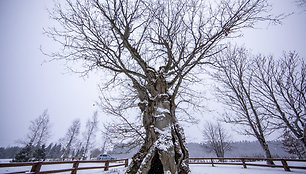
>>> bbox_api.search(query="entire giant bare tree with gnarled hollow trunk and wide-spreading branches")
[47,0,278,173]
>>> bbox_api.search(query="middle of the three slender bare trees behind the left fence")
[60,119,81,160]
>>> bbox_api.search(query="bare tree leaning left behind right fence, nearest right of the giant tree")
[213,47,274,164]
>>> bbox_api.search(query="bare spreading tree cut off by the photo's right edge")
[254,52,306,147]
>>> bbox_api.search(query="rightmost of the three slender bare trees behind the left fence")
[82,111,98,160]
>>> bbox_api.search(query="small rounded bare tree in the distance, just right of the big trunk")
[203,122,231,158]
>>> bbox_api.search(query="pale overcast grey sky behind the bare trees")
[0,0,306,146]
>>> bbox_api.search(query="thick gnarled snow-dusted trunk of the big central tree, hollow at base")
[126,73,189,174]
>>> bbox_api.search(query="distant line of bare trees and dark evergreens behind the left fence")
[0,109,101,162]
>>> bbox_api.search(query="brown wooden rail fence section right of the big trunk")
[189,158,306,171]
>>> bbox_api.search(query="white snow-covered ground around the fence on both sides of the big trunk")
[0,160,306,174]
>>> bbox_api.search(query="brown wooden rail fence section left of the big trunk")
[0,159,129,174]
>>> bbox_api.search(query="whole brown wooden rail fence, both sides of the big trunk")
[0,158,306,174]
